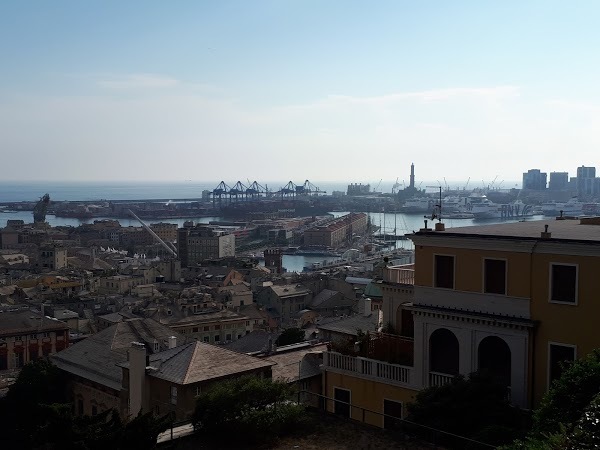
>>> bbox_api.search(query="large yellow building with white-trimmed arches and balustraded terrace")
[324,218,600,425]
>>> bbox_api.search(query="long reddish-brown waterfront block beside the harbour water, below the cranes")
[304,213,367,248]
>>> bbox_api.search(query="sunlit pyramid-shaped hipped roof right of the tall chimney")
[138,341,274,384]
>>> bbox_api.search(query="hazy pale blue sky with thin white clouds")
[0,0,600,184]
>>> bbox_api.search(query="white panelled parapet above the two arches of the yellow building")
[414,286,531,319]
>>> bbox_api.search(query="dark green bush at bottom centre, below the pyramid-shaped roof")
[193,376,304,442]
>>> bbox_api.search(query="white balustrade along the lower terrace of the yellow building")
[323,352,414,388]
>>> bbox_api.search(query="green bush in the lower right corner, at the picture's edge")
[533,350,600,435]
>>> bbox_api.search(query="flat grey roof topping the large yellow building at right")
[418,218,600,243]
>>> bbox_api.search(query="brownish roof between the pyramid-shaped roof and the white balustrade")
[268,344,327,381]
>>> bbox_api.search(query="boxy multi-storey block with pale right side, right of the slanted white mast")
[177,226,235,267]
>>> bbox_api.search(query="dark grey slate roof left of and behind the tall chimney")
[51,319,186,390]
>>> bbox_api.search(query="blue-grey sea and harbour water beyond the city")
[0,181,543,272]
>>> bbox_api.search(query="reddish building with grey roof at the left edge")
[0,309,69,370]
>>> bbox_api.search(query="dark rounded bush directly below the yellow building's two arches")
[408,372,525,445]
